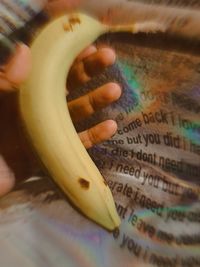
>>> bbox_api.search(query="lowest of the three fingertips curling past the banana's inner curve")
[79,120,117,149]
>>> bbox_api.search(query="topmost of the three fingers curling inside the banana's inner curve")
[68,47,116,90]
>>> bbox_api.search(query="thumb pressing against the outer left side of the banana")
[0,44,31,90]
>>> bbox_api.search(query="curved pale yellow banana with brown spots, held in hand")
[19,14,161,230]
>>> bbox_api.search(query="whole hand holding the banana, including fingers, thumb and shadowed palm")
[0,0,121,197]
